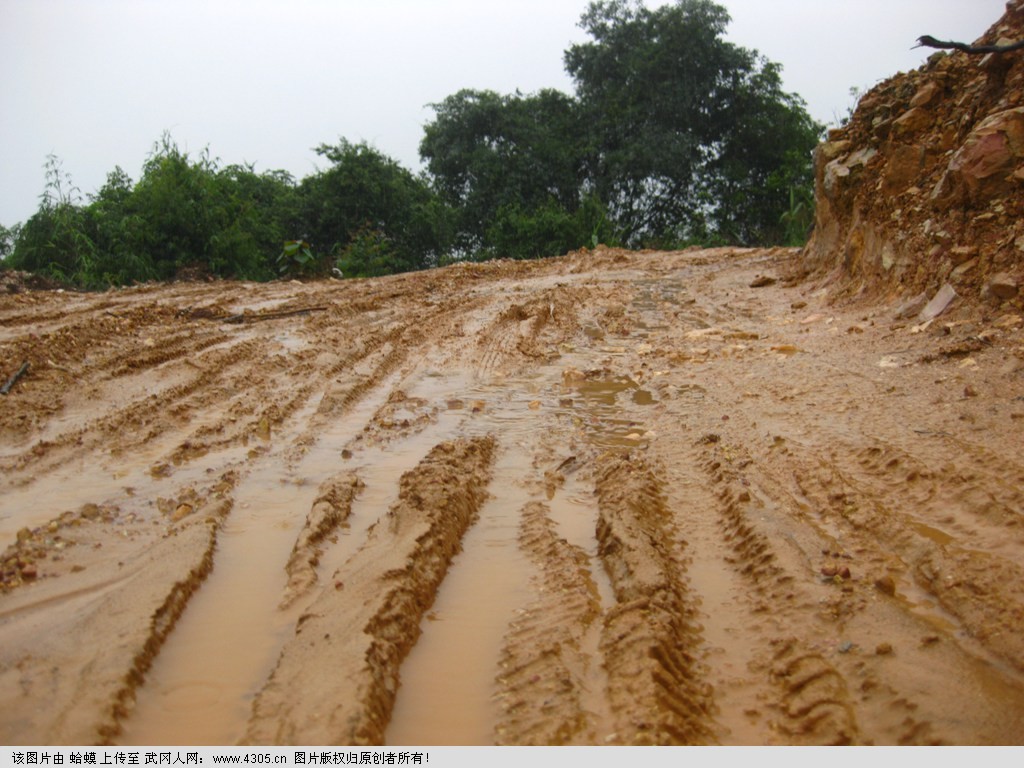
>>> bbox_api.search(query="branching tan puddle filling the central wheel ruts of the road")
[108,331,688,744]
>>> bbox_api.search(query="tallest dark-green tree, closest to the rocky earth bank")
[565,0,821,245]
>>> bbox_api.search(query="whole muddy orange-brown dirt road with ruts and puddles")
[0,249,1024,744]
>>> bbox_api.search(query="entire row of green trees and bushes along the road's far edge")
[6,0,822,288]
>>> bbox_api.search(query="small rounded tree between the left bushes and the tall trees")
[299,139,447,276]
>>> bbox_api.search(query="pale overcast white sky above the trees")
[0,0,1004,226]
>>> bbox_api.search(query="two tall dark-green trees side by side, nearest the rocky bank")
[420,0,822,257]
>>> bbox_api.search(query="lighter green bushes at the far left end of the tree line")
[9,134,299,288]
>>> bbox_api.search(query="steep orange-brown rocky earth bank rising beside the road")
[803,0,1024,308]
